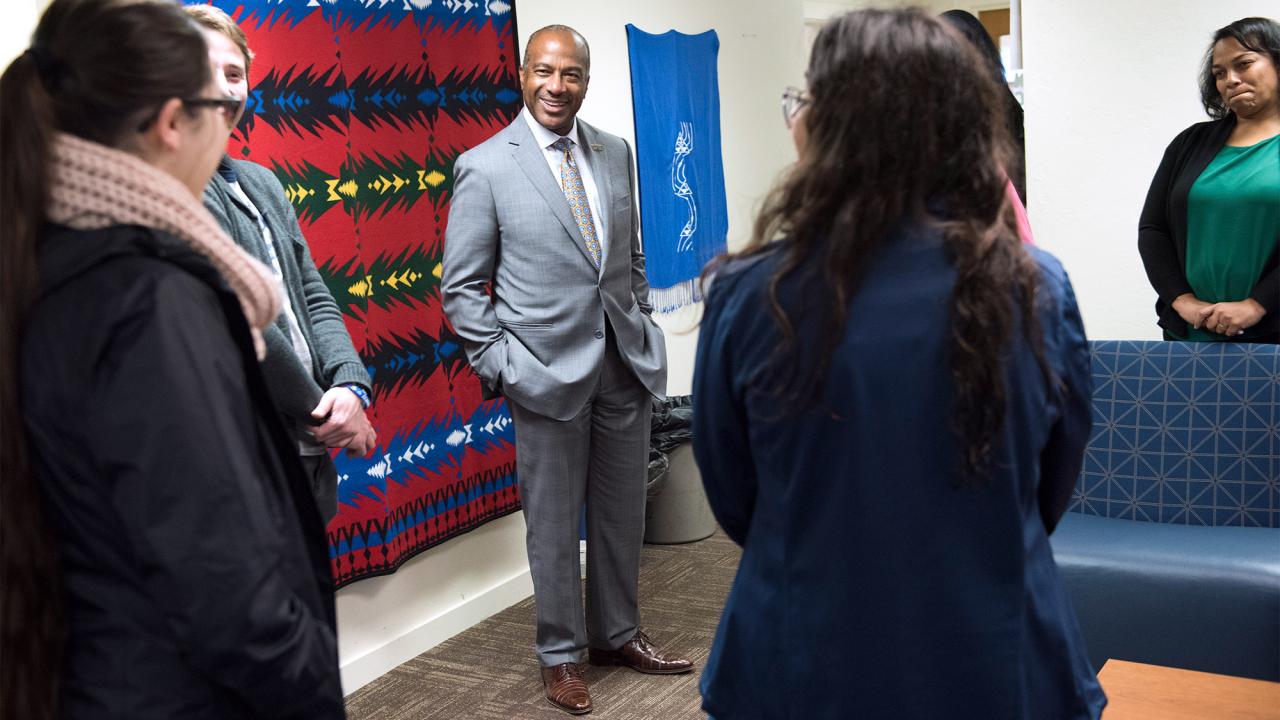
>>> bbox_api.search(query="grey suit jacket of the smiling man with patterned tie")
[442,117,667,420]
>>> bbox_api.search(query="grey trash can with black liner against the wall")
[644,395,716,544]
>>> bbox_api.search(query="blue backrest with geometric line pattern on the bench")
[1069,341,1280,528]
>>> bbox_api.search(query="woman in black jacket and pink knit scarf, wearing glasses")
[0,0,344,720]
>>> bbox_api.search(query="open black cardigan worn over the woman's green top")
[1138,115,1280,342]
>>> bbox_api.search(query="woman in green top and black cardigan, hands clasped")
[1138,18,1280,342]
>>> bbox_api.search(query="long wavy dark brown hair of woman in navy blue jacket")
[716,10,1044,480]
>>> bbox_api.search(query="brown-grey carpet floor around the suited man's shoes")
[347,532,740,720]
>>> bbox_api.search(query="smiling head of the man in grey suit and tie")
[520,31,590,135]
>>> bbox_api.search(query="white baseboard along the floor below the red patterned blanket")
[340,569,534,694]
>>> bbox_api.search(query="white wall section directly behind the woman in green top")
[1023,0,1280,340]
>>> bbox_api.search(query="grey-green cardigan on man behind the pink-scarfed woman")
[205,160,370,432]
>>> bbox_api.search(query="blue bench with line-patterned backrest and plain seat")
[1051,341,1280,680]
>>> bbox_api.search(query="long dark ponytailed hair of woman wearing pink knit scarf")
[0,0,210,720]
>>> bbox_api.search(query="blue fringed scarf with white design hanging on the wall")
[627,24,728,313]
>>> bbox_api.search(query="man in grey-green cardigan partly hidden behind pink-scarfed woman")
[187,5,378,519]
